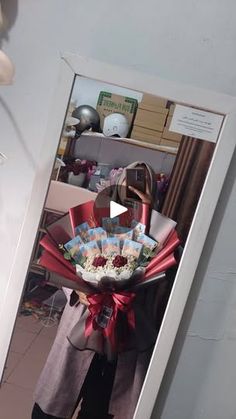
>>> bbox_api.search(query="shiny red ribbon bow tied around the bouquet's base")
[85,292,135,349]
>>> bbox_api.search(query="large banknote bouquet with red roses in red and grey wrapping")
[40,201,180,357]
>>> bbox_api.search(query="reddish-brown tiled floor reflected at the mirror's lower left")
[0,316,57,419]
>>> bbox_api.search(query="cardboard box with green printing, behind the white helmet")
[96,91,138,128]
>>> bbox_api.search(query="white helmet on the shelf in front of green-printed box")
[103,113,129,138]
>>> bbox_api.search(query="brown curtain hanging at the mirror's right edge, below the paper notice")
[161,137,215,244]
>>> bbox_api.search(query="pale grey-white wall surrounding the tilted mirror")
[0,0,236,419]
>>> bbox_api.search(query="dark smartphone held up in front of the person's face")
[126,167,146,201]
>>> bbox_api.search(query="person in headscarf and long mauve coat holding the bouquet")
[32,162,175,419]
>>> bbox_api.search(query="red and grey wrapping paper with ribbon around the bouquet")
[40,201,180,359]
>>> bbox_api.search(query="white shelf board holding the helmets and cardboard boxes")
[82,131,178,154]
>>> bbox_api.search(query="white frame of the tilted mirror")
[0,54,236,419]
